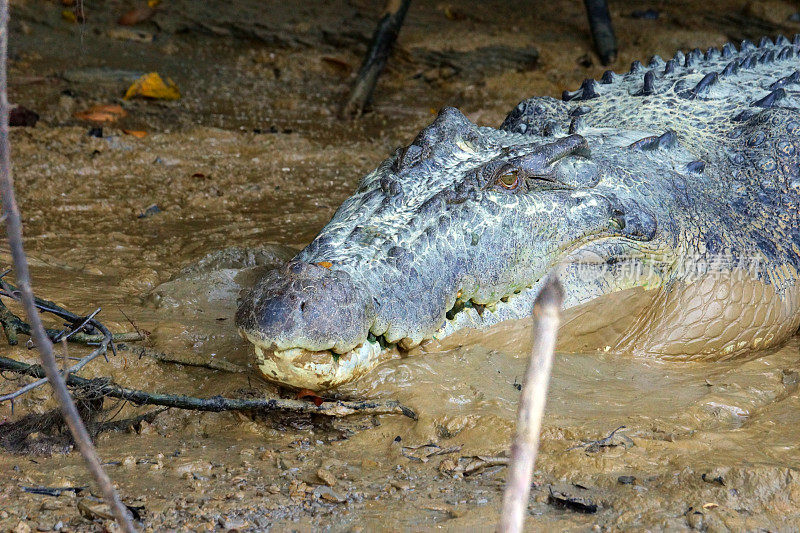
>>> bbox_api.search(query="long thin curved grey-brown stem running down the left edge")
[0,0,136,533]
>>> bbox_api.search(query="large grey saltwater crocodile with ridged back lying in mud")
[237,36,800,389]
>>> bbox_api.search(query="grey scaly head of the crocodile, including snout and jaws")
[237,108,672,390]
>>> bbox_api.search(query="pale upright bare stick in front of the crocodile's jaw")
[498,275,564,533]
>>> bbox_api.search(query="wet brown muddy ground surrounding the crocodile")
[0,0,800,531]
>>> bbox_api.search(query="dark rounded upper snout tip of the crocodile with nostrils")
[236,260,375,353]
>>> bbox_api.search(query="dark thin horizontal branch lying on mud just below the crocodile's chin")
[0,357,417,420]
